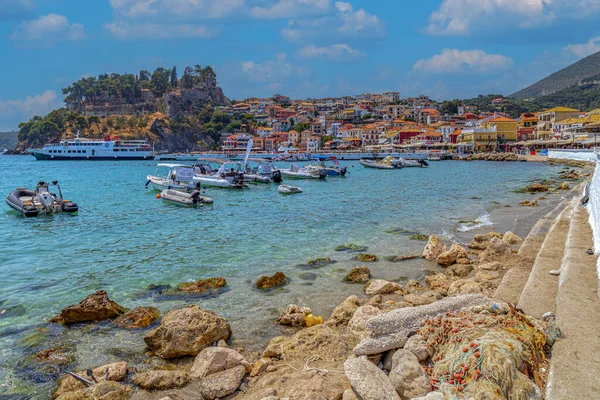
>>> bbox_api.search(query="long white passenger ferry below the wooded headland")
[27,137,156,160]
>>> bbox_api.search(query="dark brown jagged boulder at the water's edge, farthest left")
[50,290,127,325]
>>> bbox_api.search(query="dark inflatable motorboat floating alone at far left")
[6,181,79,217]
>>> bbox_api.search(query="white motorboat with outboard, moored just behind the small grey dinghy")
[192,158,248,189]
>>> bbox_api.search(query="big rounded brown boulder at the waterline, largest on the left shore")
[144,305,231,359]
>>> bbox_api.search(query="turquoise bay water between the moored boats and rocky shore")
[0,156,560,398]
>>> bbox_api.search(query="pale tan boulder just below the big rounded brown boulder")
[190,347,250,379]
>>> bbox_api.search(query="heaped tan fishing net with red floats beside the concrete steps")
[419,306,546,400]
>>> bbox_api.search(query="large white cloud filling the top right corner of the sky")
[426,0,600,35]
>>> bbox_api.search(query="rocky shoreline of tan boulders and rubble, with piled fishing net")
[32,225,555,400]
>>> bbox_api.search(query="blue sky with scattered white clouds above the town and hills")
[0,0,600,131]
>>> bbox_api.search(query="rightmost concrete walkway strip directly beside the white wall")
[546,206,600,400]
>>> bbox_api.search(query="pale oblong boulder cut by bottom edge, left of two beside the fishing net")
[344,357,400,400]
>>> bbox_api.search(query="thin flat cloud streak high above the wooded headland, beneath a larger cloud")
[103,22,215,39]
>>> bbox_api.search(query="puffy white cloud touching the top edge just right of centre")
[282,1,385,43]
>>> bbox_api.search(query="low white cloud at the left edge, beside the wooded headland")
[0,90,62,131]
